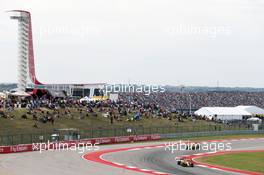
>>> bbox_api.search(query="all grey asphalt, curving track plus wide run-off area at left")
[0,139,264,175]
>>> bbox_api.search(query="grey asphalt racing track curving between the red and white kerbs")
[100,139,264,175]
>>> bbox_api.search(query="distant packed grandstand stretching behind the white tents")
[119,92,264,111]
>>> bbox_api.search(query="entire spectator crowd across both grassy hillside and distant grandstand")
[0,92,264,123]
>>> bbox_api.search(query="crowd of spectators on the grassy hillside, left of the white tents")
[0,97,169,128]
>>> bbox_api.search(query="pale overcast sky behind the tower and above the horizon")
[0,0,264,87]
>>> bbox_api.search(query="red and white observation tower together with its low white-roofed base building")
[9,10,105,97]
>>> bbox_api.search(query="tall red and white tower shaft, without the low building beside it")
[10,10,42,91]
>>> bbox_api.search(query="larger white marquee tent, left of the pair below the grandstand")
[194,107,251,120]
